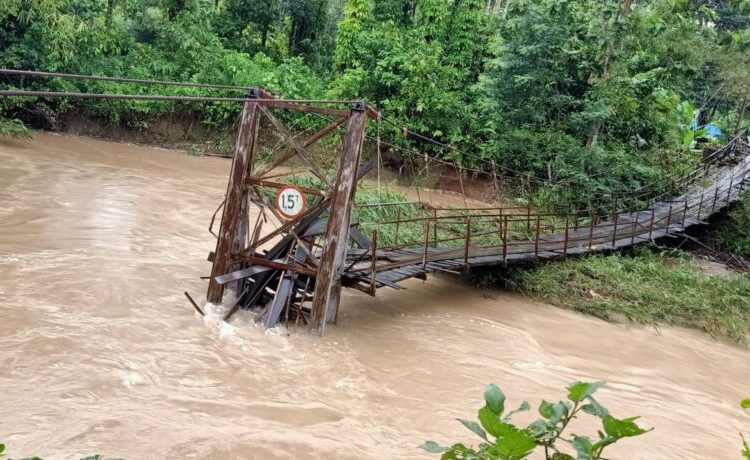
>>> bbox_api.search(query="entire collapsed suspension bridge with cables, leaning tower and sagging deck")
[0,69,750,334]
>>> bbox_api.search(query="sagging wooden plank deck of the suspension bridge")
[342,156,750,291]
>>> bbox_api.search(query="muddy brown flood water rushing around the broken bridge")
[0,134,750,460]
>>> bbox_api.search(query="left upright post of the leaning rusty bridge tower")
[206,90,260,304]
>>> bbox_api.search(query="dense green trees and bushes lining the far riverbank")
[0,0,750,205]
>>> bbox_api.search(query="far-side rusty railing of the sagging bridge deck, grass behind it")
[354,156,750,273]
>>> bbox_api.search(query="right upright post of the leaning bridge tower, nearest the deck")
[310,103,367,335]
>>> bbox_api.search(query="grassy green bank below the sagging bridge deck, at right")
[474,249,750,344]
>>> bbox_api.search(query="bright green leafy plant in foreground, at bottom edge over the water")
[422,382,649,460]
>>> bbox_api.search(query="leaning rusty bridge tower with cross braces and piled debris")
[207,89,380,334]
